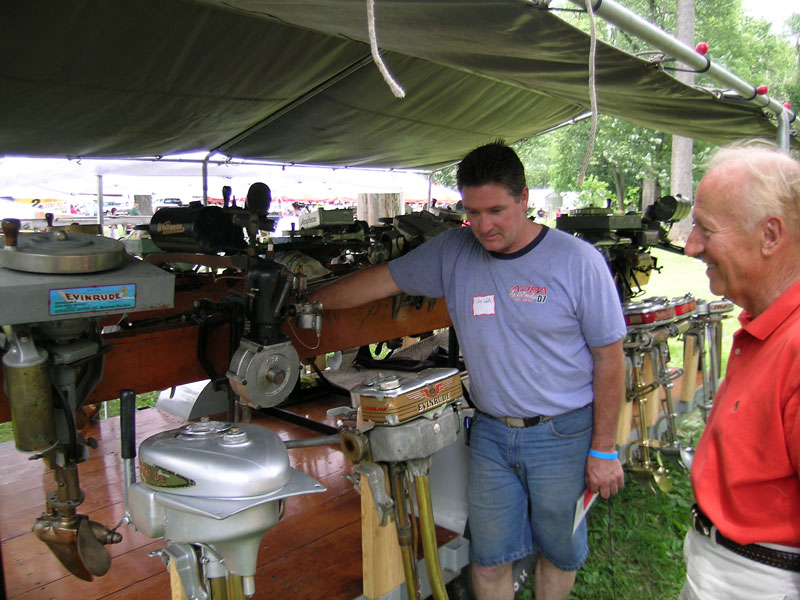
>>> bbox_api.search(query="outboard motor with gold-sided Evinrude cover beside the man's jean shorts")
[329,368,463,600]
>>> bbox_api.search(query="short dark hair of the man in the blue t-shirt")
[456,140,525,199]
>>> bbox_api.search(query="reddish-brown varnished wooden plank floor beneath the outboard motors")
[0,398,454,600]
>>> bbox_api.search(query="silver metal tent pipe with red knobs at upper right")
[570,0,797,150]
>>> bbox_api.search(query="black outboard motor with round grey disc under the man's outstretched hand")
[148,182,321,408]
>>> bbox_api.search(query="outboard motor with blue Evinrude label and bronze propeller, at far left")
[0,219,174,581]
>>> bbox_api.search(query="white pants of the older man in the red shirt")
[680,529,800,600]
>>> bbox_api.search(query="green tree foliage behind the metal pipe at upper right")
[517,0,800,208]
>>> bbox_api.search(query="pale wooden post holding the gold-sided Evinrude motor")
[361,468,405,598]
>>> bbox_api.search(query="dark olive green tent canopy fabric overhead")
[0,0,796,168]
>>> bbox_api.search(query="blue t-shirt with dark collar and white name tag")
[389,227,626,417]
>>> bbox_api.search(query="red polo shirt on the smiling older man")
[692,282,800,547]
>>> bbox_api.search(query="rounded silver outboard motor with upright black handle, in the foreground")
[121,390,325,599]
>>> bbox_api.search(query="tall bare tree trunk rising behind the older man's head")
[669,0,695,242]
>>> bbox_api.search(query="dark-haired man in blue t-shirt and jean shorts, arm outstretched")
[312,142,625,600]
